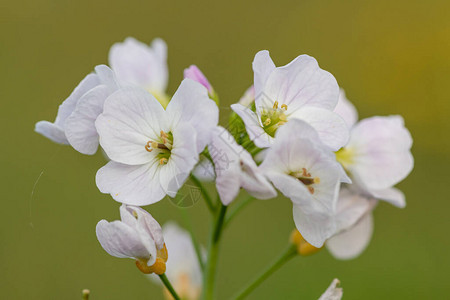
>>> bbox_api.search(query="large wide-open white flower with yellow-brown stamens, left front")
[96,79,218,206]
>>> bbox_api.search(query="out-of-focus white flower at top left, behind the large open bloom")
[109,37,169,107]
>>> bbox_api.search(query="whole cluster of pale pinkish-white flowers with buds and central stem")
[35,38,414,299]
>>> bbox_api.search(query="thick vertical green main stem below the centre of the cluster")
[203,203,227,300]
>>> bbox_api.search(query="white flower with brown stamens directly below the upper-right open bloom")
[260,120,349,248]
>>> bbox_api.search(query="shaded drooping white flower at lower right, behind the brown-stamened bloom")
[326,187,377,260]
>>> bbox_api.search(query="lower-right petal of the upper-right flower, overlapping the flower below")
[288,107,349,151]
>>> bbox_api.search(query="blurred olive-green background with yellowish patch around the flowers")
[0,0,450,300]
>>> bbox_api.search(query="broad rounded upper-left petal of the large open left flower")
[95,88,169,165]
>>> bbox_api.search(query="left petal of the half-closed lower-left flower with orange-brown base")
[96,220,156,259]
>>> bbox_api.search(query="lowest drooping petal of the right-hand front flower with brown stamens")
[293,204,336,248]
